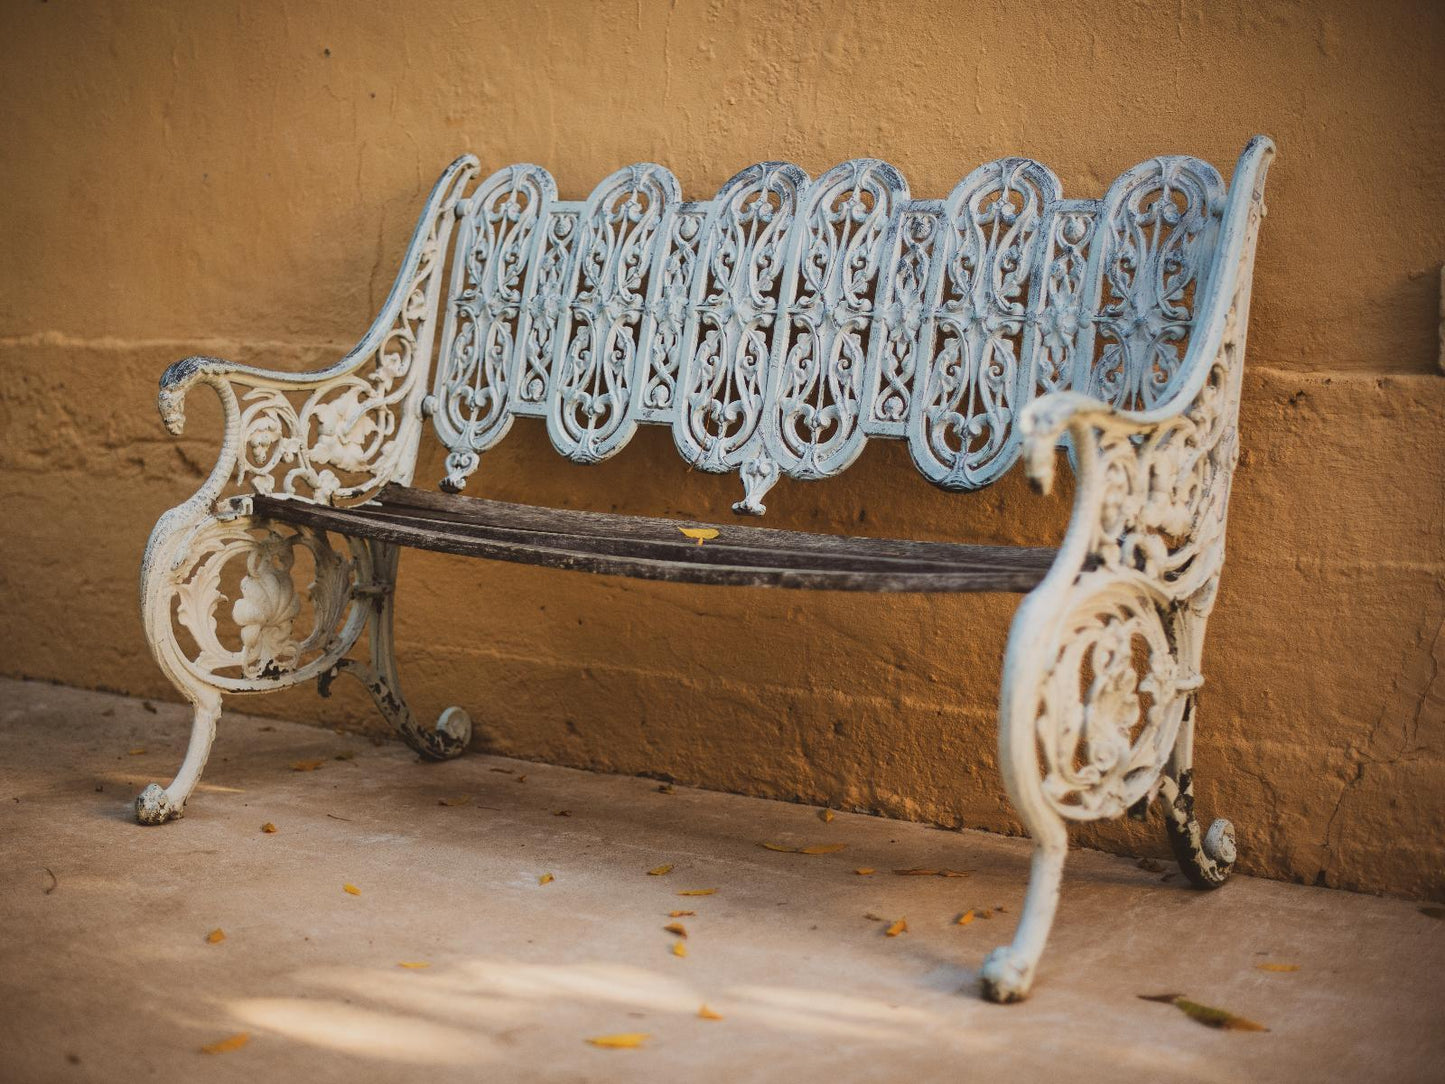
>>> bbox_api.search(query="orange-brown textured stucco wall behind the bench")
[0,0,1445,896]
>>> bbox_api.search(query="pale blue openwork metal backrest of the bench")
[425,149,1224,513]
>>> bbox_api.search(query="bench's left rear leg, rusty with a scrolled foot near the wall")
[316,539,471,760]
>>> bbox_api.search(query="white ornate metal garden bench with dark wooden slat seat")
[136,137,1274,1000]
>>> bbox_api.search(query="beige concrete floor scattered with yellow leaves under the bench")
[0,682,1445,1084]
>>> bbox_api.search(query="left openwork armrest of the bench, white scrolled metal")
[158,155,477,506]
